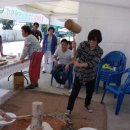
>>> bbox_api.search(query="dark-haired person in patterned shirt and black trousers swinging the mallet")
[65,29,103,116]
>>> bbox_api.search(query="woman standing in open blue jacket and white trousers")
[42,27,57,73]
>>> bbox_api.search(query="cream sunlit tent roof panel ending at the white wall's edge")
[18,0,79,22]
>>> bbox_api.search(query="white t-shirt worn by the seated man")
[54,48,74,65]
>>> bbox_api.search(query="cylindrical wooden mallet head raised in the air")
[64,19,81,33]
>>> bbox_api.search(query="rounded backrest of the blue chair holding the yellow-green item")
[105,51,126,71]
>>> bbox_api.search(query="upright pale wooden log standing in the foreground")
[30,102,44,130]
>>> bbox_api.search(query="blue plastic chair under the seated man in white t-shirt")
[51,63,74,89]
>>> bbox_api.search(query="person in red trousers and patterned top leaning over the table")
[20,25,43,89]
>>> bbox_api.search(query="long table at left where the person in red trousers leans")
[0,59,29,79]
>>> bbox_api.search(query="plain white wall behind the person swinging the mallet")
[77,3,130,67]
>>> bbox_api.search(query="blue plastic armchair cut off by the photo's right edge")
[101,68,130,115]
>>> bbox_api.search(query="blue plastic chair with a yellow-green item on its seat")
[95,51,126,93]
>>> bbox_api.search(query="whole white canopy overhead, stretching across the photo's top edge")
[0,0,130,22]
